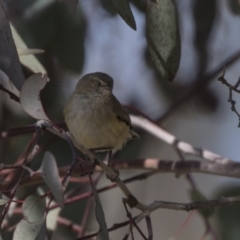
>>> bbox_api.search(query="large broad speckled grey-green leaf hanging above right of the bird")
[146,0,181,81]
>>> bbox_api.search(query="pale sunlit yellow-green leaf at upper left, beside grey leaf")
[10,25,47,73]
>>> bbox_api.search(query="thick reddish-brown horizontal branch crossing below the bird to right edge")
[3,158,240,190]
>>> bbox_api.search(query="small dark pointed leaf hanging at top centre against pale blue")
[111,0,137,30]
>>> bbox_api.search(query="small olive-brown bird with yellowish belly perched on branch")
[64,72,139,151]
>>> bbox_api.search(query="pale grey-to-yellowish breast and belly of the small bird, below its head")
[65,93,131,149]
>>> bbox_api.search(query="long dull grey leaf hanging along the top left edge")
[0,1,25,90]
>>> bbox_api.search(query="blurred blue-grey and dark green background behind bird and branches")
[0,0,240,240]
